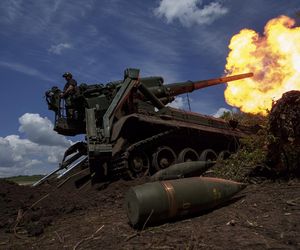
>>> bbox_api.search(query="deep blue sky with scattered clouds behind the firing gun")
[0,0,300,177]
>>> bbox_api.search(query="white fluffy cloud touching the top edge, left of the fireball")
[154,0,228,26]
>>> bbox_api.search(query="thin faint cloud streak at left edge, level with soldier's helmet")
[0,61,53,82]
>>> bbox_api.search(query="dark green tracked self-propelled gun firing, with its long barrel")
[35,69,252,186]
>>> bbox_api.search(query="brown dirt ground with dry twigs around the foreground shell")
[0,177,300,249]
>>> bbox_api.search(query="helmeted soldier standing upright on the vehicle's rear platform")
[60,72,77,118]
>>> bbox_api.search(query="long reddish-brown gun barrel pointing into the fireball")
[166,73,253,96]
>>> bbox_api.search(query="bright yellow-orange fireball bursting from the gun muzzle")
[225,16,300,115]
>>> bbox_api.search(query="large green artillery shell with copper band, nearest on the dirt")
[125,177,246,226]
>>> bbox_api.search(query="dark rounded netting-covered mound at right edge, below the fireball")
[268,90,300,176]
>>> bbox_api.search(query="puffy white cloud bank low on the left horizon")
[0,113,72,177]
